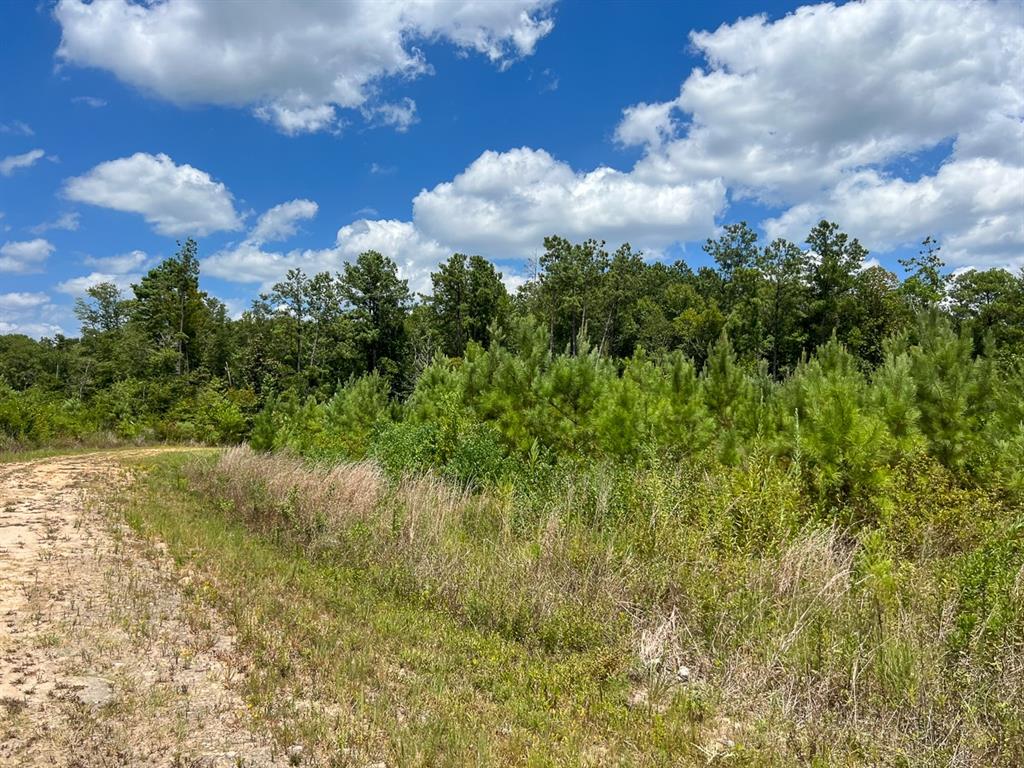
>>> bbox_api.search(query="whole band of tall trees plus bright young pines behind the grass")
[0,221,1024,514]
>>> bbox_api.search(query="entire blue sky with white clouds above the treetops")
[0,0,1024,336]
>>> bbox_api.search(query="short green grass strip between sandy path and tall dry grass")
[114,454,720,766]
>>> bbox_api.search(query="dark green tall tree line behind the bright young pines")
[0,221,1024,456]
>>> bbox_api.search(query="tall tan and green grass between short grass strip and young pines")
[191,447,1024,766]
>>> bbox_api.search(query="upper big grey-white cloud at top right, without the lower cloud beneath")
[616,0,1024,200]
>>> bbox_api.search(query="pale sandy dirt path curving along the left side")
[0,449,288,768]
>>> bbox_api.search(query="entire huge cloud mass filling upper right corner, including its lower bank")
[615,0,1024,263]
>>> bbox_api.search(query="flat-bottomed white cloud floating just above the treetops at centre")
[413,147,725,258]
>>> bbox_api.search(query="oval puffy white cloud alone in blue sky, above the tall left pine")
[63,153,242,236]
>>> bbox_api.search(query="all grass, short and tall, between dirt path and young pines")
[108,449,1024,767]
